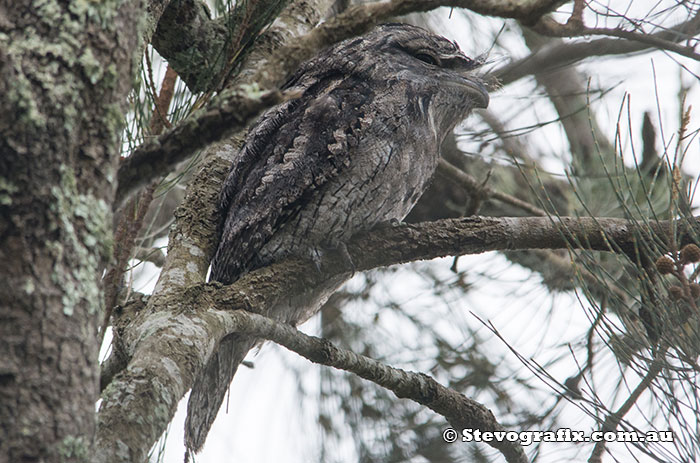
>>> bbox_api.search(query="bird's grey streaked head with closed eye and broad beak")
[284,24,489,139]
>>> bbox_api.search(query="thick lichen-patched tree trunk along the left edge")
[0,0,145,461]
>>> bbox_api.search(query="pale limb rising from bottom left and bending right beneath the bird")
[99,217,700,461]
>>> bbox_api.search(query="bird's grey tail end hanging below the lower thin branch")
[185,333,259,452]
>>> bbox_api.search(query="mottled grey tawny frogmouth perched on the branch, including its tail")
[186,24,489,451]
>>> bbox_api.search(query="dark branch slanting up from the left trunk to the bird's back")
[114,87,282,209]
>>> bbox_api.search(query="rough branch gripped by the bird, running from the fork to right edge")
[106,212,700,355]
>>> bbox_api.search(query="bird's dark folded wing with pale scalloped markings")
[211,80,372,283]
